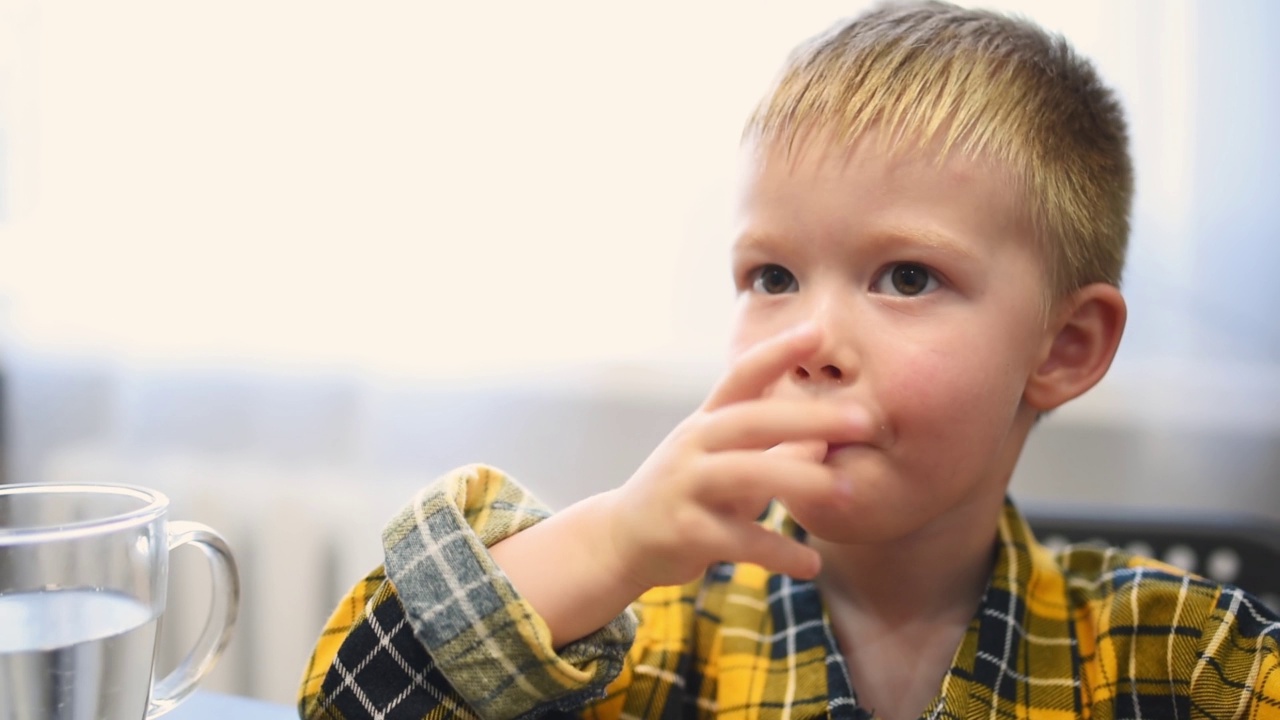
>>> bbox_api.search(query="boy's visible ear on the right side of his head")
[1023,283,1128,413]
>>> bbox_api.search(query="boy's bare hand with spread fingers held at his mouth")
[600,322,870,594]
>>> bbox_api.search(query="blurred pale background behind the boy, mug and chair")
[0,0,1280,702]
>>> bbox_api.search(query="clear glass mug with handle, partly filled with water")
[0,484,239,720]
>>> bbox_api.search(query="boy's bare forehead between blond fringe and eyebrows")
[732,126,1036,263]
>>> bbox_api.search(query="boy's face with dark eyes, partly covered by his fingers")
[732,130,1051,542]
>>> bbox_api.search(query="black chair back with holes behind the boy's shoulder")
[1021,505,1280,612]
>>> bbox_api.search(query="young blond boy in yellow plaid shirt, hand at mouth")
[300,3,1280,720]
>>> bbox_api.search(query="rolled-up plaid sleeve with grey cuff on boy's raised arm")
[298,466,635,720]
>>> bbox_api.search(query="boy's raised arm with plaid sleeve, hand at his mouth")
[301,328,876,720]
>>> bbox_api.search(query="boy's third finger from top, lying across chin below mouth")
[694,450,851,509]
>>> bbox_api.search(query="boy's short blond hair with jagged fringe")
[744,1,1133,300]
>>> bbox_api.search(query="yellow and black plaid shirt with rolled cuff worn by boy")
[298,466,1280,720]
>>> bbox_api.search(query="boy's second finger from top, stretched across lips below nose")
[699,398,876,452]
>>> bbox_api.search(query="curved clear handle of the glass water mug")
[146,520,239,720]
